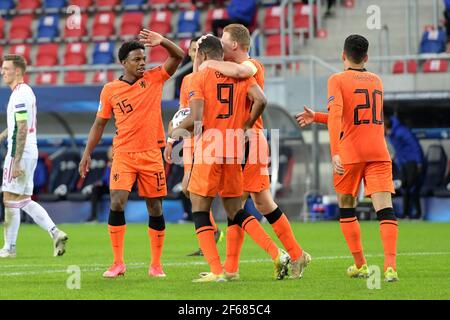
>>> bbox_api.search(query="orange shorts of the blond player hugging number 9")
[243,133,270,193]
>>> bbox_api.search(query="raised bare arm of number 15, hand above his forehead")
[139,29,184,75]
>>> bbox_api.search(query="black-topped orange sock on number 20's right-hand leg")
[377,208,398,271]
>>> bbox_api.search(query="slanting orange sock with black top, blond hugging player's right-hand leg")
[264,208,303,261]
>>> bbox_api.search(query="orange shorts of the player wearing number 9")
[188,163,243,198]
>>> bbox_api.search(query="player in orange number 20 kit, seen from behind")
[297,35,398,282]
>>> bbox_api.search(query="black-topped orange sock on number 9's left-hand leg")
[192,211,223,274]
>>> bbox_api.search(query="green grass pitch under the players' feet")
[0,221,450,300]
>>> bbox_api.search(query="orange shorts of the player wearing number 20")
[333,161,395,197]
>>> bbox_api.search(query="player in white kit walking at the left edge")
[0,55,68,258]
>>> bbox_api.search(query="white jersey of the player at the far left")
[6,83,38,159]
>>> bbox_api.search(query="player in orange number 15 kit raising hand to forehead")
[79,35,184,278]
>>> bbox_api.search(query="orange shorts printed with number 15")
[109,149,167,198]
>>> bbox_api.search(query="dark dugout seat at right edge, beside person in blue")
[420,144,448,197]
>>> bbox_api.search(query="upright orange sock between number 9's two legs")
[224,219,245,272]
